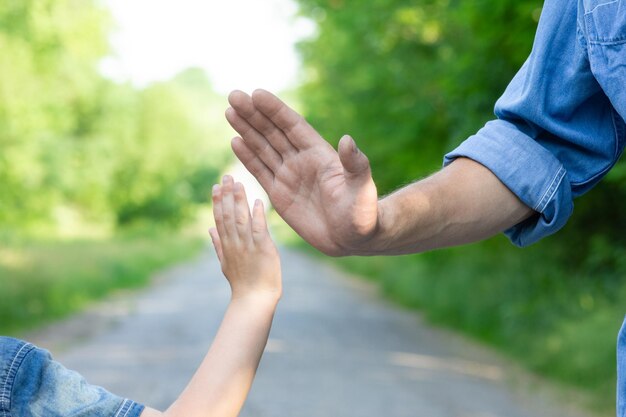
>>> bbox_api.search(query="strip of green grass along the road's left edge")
[0,233,202,334]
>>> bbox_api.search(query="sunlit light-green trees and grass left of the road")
[0,0,230,334]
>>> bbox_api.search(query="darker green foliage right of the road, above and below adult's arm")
[298,0,626,404]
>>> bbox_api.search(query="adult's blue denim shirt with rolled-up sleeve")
[444,0,626,417]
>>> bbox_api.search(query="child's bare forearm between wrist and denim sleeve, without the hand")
[165,297,278,417]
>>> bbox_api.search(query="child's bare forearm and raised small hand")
[141,176,282,417]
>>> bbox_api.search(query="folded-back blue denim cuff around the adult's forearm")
[444,120,574,246]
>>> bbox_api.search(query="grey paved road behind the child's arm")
[28,247,596,417]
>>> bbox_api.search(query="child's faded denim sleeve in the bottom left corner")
[0,337,144,417]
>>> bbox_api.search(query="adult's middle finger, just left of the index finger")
[228,90,296,155]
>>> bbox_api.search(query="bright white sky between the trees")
[101,0,314,94]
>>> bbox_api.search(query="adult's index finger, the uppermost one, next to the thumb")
[252,90,330,150]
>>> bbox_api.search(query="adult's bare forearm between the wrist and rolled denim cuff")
[358,158,535,255]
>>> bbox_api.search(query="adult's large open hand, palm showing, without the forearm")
[226,90,380,256]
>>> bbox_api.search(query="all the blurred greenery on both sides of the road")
[0,0,626,410]
